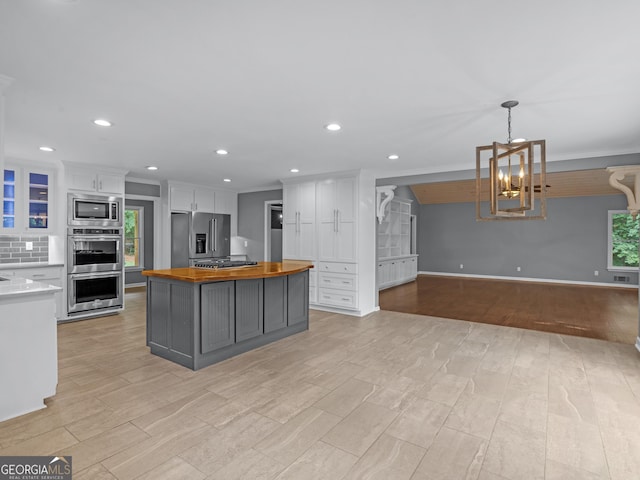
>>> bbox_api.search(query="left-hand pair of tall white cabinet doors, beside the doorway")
[282,182,316,260]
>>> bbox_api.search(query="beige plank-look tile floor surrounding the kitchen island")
[0,286,640,480]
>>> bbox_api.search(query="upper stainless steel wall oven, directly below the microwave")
[67,227,123,273]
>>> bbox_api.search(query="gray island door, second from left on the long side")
[236,278,264,342]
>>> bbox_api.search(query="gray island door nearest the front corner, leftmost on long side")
[200,282,236,353]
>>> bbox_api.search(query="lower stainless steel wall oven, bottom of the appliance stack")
[67,271,124,314]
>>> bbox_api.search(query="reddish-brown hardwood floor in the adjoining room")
[380,275,638,344]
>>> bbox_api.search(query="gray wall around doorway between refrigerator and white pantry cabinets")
[238,189,282,261]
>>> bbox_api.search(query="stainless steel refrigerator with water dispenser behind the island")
[171,212,231,268]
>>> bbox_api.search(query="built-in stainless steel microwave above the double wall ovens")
[67,193,122,227]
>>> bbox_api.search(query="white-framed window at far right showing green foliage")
[607,210,638,271]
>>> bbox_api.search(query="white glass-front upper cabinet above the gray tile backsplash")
[0,162,53,233]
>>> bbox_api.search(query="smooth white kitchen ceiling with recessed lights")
[0,0,640,191]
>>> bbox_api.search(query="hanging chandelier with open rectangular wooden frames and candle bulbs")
[476,100,547,220]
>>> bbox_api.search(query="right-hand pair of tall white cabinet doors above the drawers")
[318,177,358,262]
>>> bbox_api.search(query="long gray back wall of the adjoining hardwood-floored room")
[418,194,638,283]
